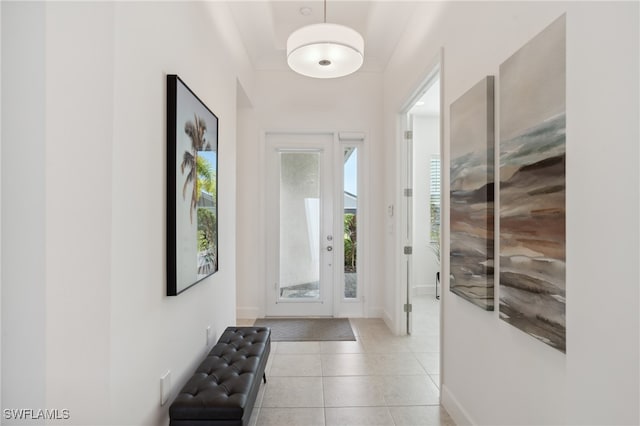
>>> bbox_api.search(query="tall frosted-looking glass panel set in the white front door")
[278,152,320,300]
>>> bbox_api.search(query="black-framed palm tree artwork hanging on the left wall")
[167,74,218,296]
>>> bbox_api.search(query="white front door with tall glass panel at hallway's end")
[266,133,336,316]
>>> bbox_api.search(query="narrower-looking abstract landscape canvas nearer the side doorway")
[449,76,495,311]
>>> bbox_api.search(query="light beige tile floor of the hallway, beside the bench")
[239,296,454,426]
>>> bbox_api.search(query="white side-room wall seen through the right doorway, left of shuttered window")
[411,115,440,295]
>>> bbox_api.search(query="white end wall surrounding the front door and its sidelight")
[237,71,387,318]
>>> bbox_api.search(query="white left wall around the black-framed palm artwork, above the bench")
[2,2,253,425]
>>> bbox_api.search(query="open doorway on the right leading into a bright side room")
[400,59,442,365]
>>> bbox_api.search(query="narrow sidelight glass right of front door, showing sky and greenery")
[343,147,358,299]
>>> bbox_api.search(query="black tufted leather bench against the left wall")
[169,327,271,426]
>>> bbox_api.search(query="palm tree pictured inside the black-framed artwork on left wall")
[180,114,211,223]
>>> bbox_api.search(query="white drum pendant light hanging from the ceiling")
[287,0,364,78]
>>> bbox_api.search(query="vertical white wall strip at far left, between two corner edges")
[44,3,114,421]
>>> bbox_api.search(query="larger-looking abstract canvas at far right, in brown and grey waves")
[499,16,566,352]
